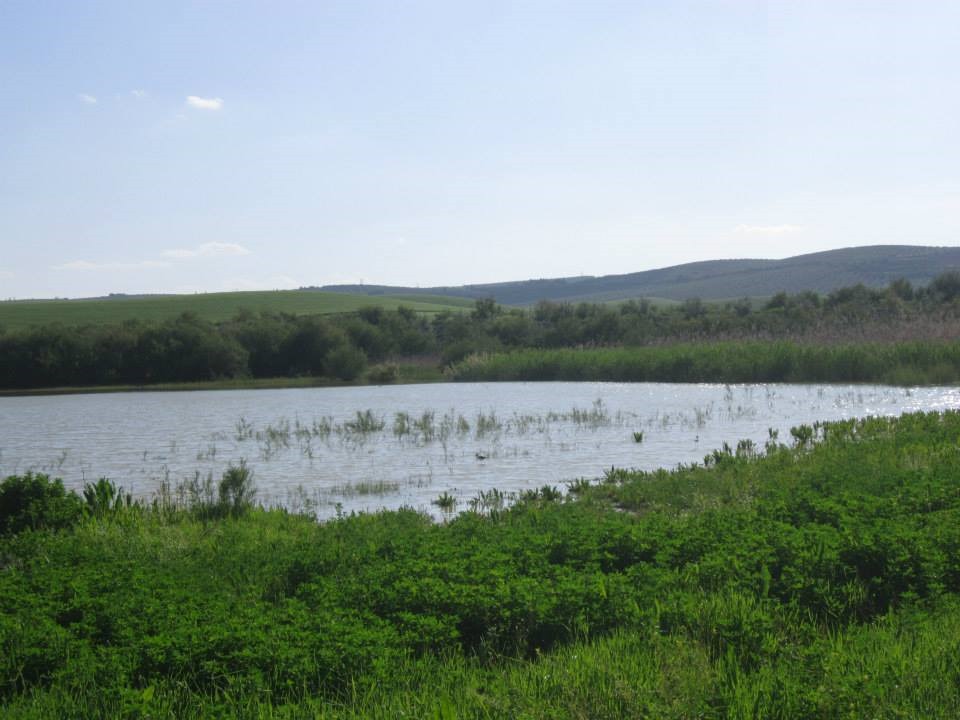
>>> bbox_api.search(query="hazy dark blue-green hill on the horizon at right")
[318,245,960,305]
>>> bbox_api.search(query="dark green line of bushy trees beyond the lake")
[0,272,960,389]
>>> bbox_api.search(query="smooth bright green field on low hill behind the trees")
[0,290,473,330]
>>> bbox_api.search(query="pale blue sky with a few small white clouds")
[0,0,960,298]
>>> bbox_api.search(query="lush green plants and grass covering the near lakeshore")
[0,412,960,719]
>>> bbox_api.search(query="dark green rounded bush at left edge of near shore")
[0,472,83,535]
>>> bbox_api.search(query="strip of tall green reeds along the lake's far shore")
[449,341,960,385]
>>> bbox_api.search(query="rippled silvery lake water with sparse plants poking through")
[0,383,960,517]
